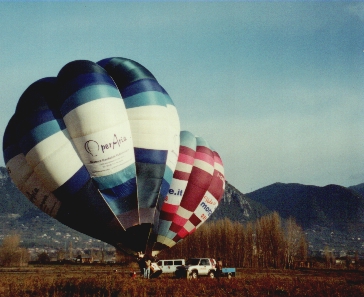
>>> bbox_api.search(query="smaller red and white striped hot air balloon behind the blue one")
[154,131,225,251]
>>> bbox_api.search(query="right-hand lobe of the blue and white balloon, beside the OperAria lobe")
[98,58,180,246]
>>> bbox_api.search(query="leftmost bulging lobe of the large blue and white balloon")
[3,78,122,247]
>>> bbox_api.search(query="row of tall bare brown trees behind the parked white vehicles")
[158,212,308,268]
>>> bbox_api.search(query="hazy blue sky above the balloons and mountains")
[0,1,364,193]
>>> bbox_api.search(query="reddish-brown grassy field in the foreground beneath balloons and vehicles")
[0,265,364,297]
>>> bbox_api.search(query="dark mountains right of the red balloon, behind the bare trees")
[218,183,364,252]
